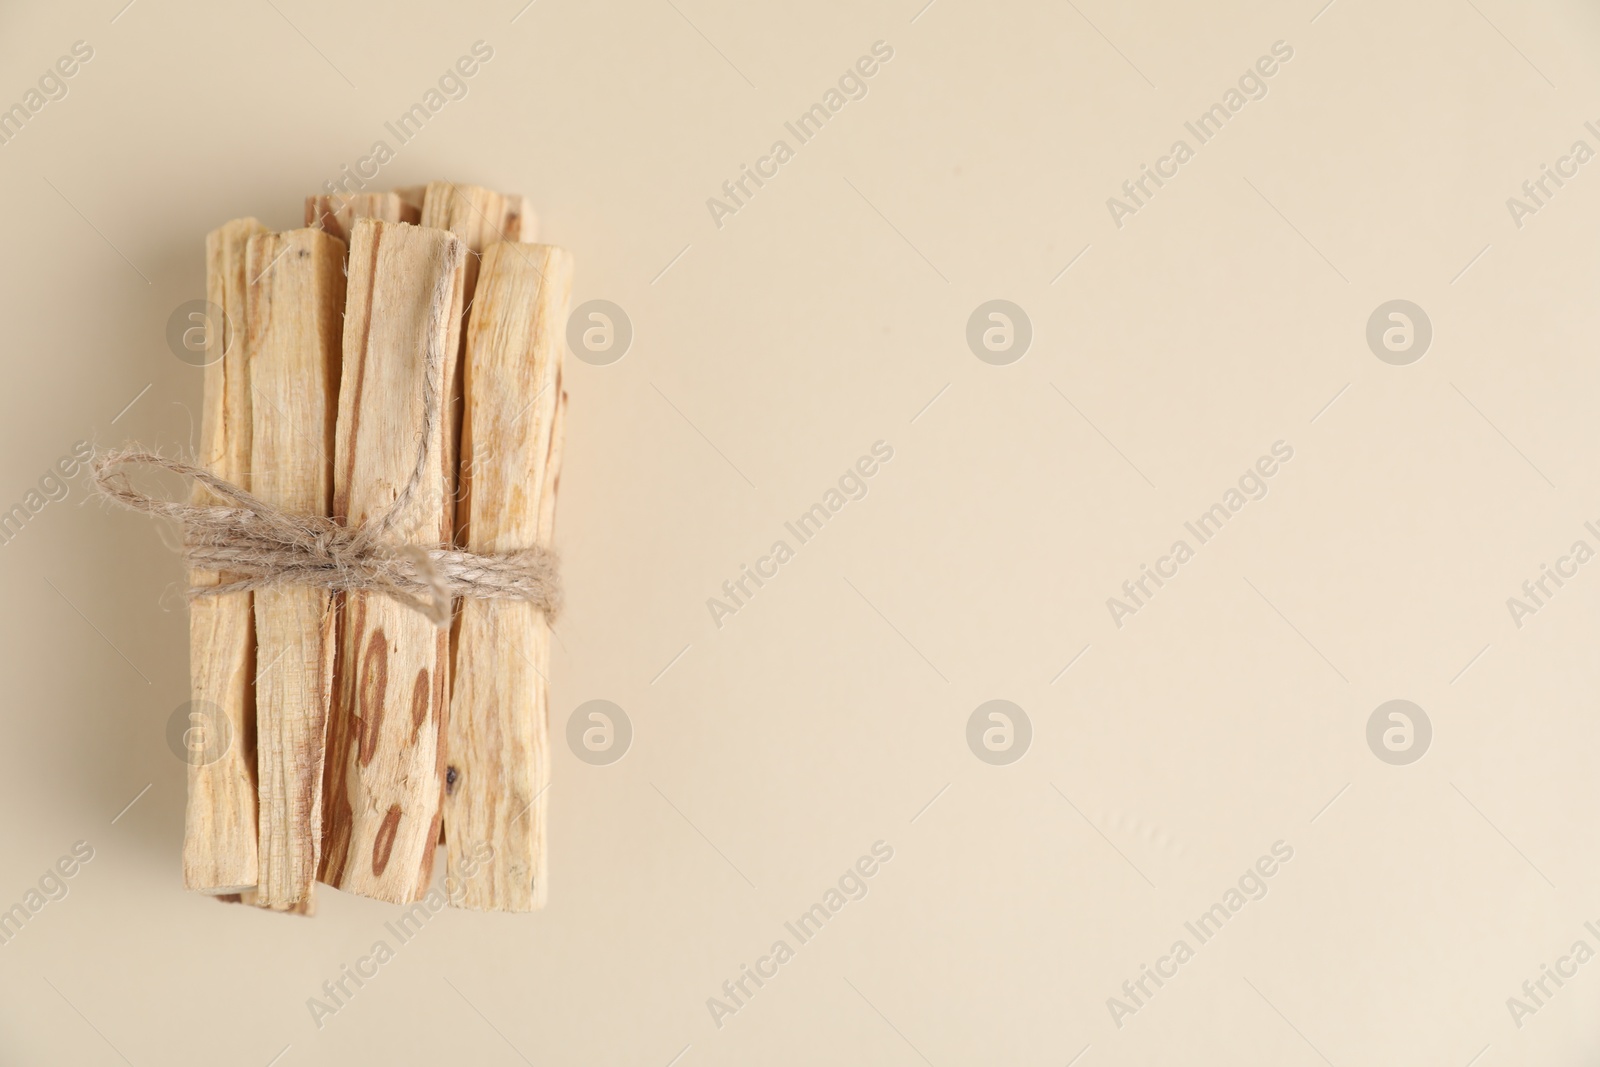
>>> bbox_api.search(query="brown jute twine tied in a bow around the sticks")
[93,271,562,627]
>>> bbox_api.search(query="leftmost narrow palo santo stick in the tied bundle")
[184,219,266,893]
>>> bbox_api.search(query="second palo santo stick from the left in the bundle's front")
[248,229,344,909]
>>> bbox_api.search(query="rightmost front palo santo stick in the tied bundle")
[445,243,573,912]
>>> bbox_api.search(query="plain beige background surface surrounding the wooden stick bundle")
[0,0,1600,1067]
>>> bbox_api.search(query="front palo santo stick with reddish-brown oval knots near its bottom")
[322,219,467,904]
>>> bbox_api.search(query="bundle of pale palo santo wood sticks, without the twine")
[165,182,573,913]
